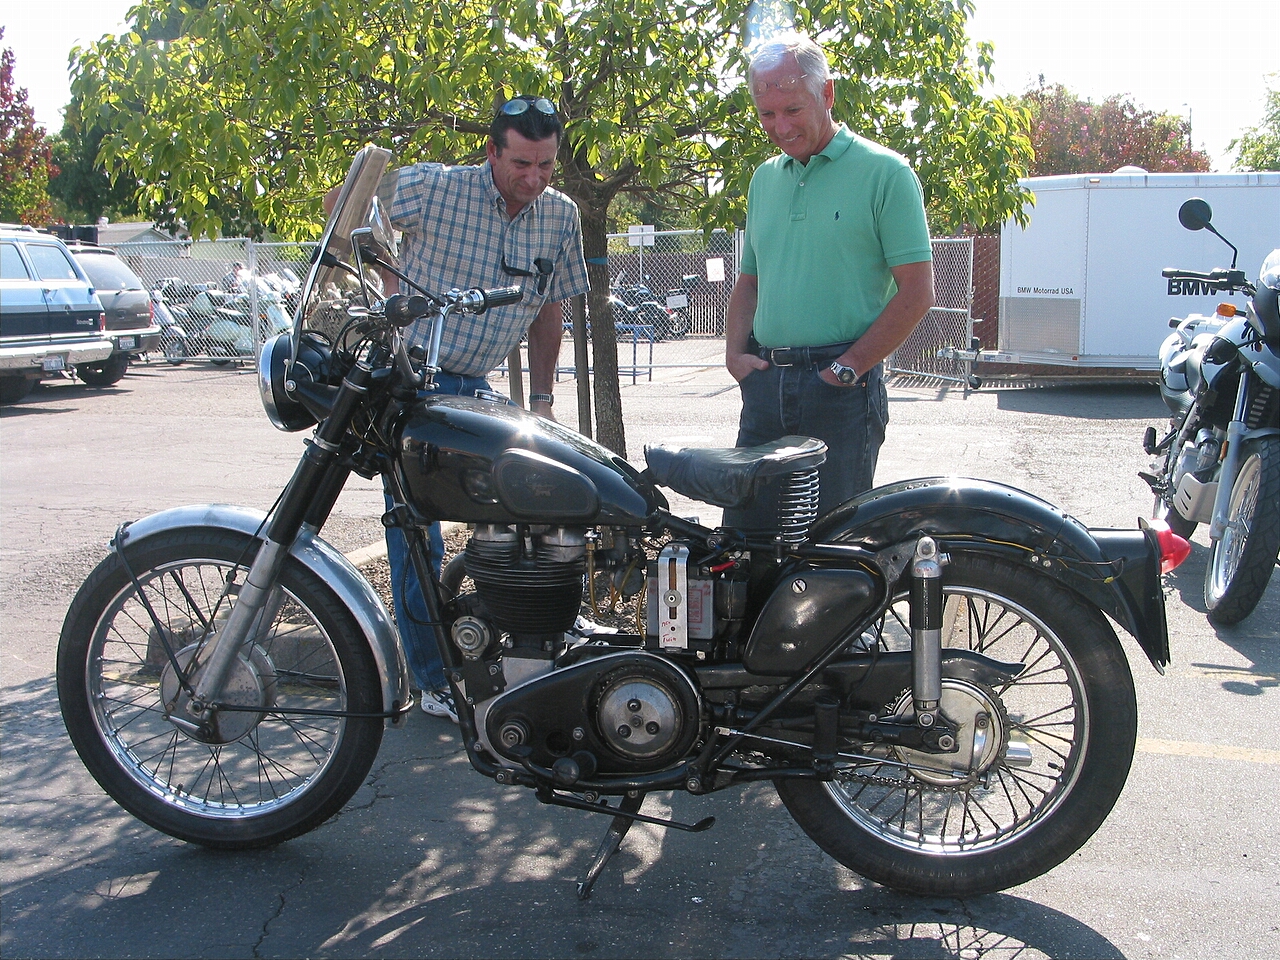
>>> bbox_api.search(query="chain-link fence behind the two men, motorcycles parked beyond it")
[114,228,977,381]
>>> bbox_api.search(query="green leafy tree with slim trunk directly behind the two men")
[73,0,1030,451]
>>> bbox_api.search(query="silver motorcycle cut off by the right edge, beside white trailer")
[1140,198,1280,625]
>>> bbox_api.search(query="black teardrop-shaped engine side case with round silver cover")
[485,650,701,774]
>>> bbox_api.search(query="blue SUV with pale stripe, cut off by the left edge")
[0,227,115,403]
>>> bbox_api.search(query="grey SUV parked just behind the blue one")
[69,243,161,387]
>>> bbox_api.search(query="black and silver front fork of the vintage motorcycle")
[187,362,371,722]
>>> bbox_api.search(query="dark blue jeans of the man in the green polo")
[724,364,888,530]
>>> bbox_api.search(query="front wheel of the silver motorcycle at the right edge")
[1204,436,1280,626]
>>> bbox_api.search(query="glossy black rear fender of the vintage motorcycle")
[809,477,1169,673]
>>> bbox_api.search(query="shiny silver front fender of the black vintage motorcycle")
[119,503,410,726]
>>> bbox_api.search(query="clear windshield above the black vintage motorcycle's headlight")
[293,143,399,356]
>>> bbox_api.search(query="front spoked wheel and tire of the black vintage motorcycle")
[58,529,383,850]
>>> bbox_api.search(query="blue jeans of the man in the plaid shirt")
[387,372,493,690]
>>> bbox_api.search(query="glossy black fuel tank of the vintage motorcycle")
[396,396,667,526]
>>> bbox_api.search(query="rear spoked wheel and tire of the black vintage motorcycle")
[774,554,1138,897]
